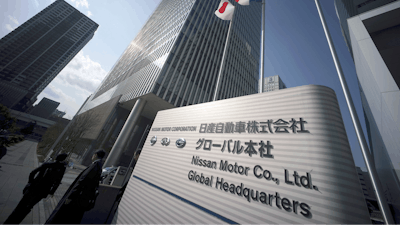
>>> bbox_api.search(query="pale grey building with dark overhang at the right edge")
[335,0,400,221]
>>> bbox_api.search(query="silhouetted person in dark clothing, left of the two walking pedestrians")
[4,153,68,224]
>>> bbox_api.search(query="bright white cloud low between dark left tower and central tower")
[56,51,107,93]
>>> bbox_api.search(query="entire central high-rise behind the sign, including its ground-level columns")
[78,0,262,164]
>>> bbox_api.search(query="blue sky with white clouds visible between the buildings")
[0,0,367,167]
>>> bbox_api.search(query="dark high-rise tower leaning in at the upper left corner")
[0,0,99,111]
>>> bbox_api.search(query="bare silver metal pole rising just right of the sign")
[315,0,394,225]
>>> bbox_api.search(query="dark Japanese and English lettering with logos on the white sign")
[150,118,318,217]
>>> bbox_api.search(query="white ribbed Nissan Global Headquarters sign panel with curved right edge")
[113,85,371,224]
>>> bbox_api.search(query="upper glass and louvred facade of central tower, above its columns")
[84,0,261,108]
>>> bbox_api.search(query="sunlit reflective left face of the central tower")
[95,1,191,97]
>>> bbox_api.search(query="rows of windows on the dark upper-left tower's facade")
[0,1,97,96]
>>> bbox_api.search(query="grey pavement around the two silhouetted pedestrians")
[0,140,86,224]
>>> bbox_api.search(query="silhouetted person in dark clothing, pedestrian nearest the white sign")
[45,150,106,224]
